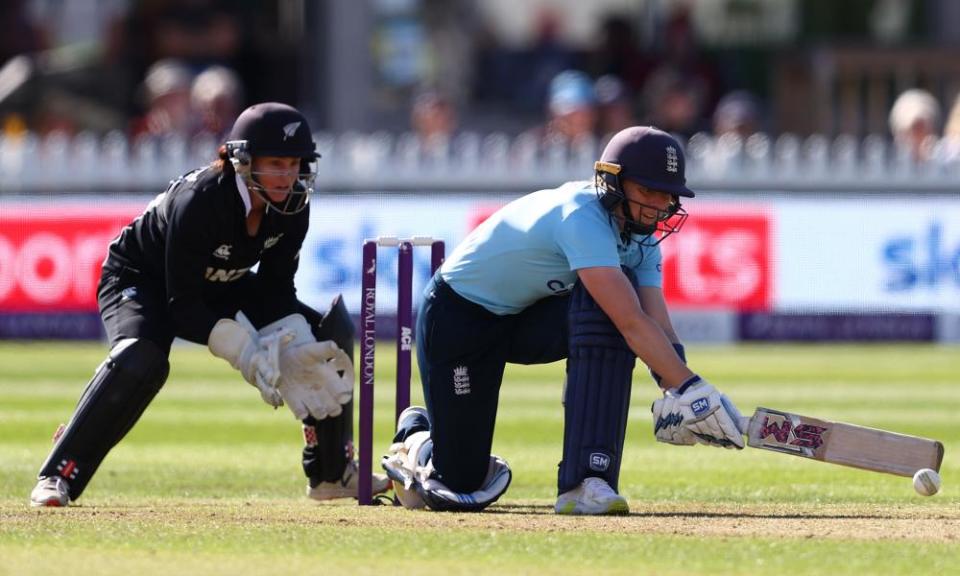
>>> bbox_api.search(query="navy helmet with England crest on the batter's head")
[593,126,694,245]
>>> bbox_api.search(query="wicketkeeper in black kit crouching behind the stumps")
[30,103,387,506]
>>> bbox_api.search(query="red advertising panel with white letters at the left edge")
[0,202,143,312]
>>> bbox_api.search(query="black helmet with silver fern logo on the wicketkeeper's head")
[225,102,320,214]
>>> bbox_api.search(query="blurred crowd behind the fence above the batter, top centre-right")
[410,10,770,148]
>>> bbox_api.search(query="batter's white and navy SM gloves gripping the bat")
[651,375,744,450]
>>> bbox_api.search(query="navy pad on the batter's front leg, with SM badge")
[558,274,636,494]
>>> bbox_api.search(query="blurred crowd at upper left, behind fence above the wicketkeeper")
[0,0,298,138]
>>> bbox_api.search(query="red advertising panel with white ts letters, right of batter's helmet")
[660,206,774,311]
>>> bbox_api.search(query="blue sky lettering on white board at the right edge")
[882,221,960,292]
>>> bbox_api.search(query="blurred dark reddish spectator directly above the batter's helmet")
[642,68,707,138]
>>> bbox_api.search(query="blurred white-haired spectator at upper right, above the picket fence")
[890,88,940,162]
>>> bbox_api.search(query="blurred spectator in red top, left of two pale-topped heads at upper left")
[131,59,194,136]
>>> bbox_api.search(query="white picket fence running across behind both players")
[0,133,960,193]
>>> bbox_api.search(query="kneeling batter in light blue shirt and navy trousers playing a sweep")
[383,127,744,514]
